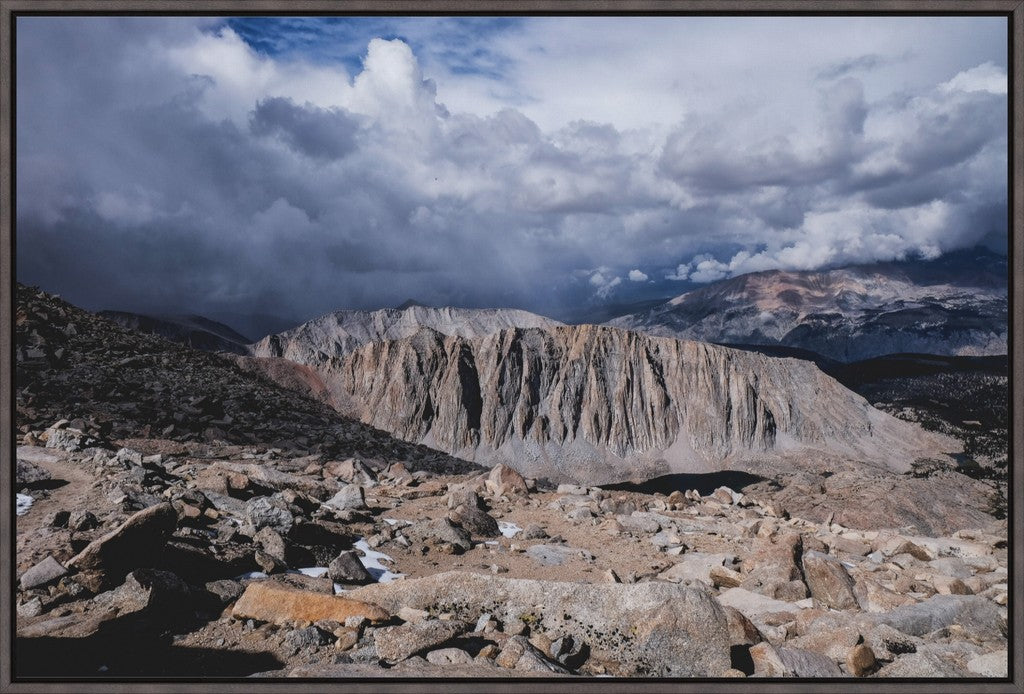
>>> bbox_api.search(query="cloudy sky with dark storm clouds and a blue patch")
[15,16,1008,337]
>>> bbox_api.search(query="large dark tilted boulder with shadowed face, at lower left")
[68,503,178,592]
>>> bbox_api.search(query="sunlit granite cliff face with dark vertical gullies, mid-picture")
[278,326,951,483]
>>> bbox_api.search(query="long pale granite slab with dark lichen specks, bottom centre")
[348,571,730,677]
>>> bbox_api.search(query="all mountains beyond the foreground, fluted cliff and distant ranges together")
[96,251,1007,483]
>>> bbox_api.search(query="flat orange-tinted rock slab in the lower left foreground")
[231,582,391,624]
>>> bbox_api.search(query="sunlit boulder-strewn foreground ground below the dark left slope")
[15,434,1008,678]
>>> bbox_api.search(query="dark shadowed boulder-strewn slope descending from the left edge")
[14,285,475,479]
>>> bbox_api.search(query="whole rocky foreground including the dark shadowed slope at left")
[14,287,1009,678]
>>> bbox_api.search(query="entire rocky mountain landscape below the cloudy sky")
[15,251,1009,678]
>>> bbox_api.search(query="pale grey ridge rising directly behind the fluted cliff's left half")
[250,302,561,368]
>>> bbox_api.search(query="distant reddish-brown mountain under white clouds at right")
[607,250,1008,361]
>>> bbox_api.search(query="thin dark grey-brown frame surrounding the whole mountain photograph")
[0,0,1024,694]
